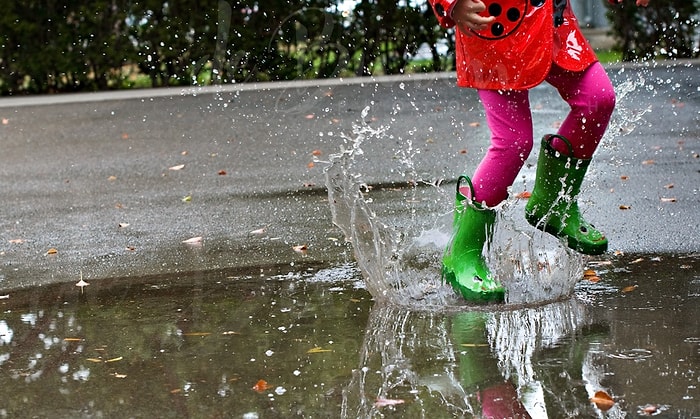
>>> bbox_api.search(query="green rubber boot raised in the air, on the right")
[525,135,608,255]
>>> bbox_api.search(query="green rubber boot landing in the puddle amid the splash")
[442,175,505,303]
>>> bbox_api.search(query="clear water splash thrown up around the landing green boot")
[326,107,583,309]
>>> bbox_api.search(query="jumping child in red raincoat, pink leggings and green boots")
[429,0,649,301]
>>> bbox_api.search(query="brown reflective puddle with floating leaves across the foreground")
[0,256,700,418]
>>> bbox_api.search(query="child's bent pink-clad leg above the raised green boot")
[547,63,615,159]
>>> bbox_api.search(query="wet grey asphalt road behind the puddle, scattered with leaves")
[0,62,700,290]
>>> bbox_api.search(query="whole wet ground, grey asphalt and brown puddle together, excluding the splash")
[0,63,700,417]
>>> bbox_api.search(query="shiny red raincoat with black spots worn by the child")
[429,0,597,90]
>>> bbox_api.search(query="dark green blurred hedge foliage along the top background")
[0,0,700,95]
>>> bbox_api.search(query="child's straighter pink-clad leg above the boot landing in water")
[472,90,533,207]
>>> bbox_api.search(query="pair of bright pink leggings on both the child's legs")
[472,63,615,206]
